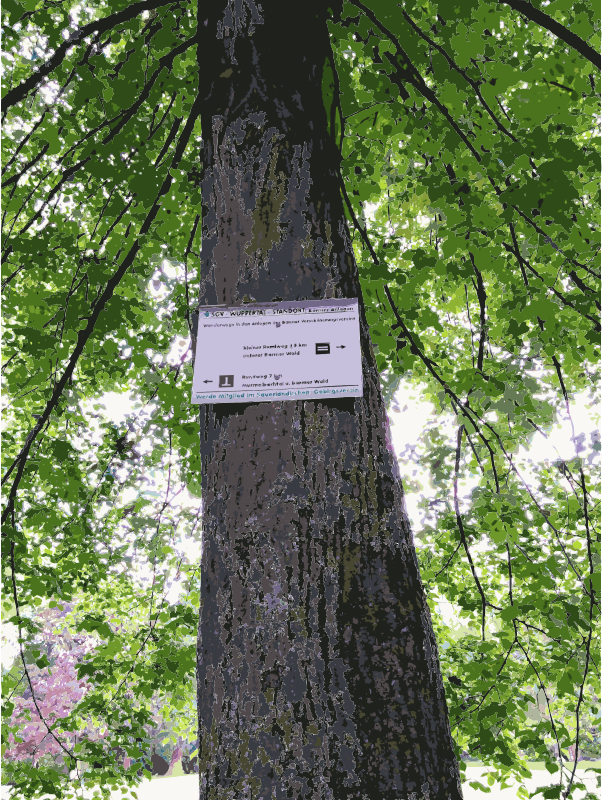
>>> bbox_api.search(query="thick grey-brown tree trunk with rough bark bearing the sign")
[197,0,462,800]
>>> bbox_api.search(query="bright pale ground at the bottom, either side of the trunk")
[2,761,602,800]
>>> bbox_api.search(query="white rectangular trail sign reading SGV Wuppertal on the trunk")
[192,299,363,403]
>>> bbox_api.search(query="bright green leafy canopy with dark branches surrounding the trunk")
[1,0,601,797]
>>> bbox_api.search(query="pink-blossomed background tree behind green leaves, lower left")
[3,598,196,778]
